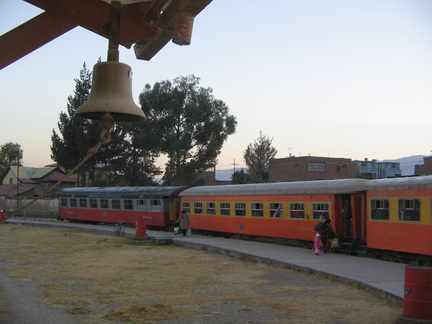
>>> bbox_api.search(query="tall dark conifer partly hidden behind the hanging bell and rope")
[51,63,160,186]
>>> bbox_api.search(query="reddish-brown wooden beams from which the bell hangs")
[0,0,212,69]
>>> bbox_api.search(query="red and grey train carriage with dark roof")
[58,187,186,227]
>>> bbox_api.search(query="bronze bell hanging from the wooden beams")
[75,61,145,122]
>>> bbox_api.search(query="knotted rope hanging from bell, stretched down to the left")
[6,113,114,219]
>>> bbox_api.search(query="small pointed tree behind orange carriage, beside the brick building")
[243,131,277,182]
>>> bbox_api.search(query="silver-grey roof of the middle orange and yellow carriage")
[180,179,369,196]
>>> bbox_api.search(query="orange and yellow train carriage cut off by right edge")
[367,176,432,256]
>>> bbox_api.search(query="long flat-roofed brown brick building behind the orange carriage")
[269,156,358,182]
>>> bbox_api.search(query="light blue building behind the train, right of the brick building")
[355,159,402,179]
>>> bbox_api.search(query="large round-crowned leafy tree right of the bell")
[140,75,237,185]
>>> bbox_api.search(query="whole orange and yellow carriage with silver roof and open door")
[180,179,368,241]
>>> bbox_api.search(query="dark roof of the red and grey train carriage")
[58,187,188,198]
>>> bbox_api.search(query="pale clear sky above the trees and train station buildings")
[0,0,432,170]
